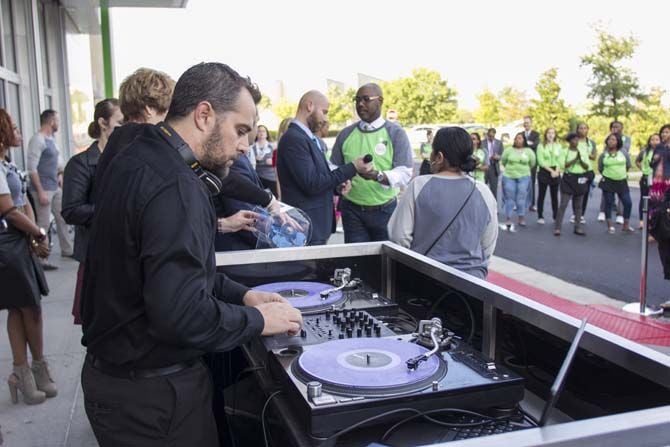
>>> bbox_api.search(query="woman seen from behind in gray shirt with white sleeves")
[388,127,498,279]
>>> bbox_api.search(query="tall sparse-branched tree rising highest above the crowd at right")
[581,28,646,120]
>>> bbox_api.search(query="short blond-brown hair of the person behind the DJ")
[119,68,175,121]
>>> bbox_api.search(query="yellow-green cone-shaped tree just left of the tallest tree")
[528,68,572,136]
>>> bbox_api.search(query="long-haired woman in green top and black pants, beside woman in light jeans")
[537,127,563,225]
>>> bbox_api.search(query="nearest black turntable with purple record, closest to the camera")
[269,319,524,437]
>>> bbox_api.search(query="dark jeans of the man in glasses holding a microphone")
[342,198,398,244]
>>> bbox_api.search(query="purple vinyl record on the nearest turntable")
[294,338,446,395]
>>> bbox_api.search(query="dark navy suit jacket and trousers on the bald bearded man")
[277,123,356,244]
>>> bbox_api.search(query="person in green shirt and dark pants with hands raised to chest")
[554,133,592,236]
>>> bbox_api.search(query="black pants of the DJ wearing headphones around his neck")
[81,361,219,447]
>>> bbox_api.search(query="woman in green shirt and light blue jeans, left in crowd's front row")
[501,132,535,231]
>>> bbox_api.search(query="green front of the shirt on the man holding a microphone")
[342,126,398,206]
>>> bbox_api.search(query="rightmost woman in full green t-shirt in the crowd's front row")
[598,133,634,234]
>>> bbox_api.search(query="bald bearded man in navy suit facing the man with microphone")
[277,90,372,245]
